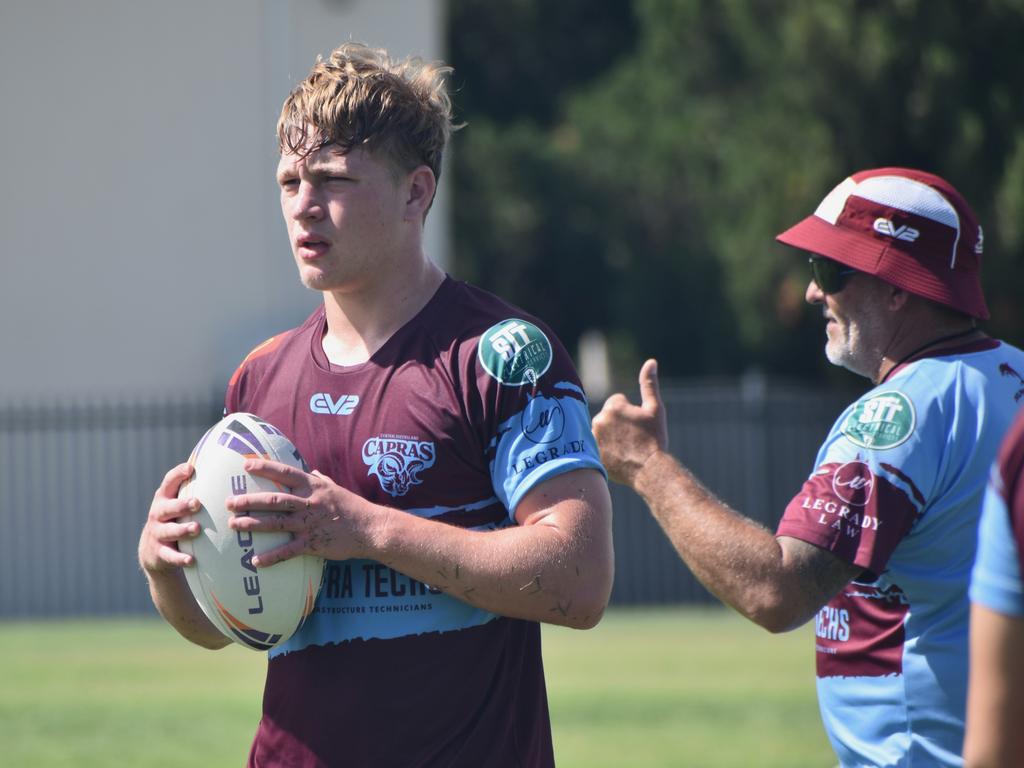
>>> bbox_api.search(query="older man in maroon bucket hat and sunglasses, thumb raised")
[594,168,1024,766]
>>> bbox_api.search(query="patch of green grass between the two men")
[544,608,836,768]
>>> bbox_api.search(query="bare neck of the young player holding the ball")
[322,258,444,366]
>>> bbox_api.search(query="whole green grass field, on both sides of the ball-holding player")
[0,608,836,768]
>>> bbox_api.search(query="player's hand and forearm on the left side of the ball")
[138,464,230,648]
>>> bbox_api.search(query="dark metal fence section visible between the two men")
[611,377,851,605]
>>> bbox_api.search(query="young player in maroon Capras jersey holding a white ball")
[139,44,612,766]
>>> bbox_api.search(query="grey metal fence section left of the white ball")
[0,399,219,616]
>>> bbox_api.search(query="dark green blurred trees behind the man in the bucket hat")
[447,0,1024,384]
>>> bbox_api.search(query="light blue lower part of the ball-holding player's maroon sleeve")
[490,382,605,517]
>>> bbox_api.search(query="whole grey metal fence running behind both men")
[0,378,845,617]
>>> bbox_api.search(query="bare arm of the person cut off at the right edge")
[964,603,1024,768]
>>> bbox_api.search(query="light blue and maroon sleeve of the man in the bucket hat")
[776,390,946,574]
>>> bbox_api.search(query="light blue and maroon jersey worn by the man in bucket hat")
[776,340,1024,767]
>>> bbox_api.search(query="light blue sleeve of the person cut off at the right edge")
[971,483,1024,615]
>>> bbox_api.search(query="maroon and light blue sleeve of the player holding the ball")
[474,317,605,517]
